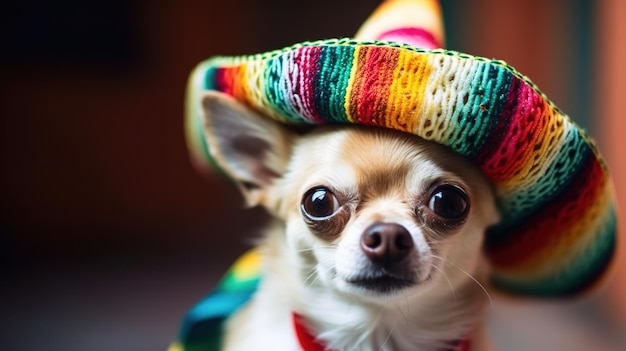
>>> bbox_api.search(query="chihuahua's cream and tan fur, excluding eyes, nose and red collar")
[205,93,498,351]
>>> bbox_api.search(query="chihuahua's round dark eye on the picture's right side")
[428,184,469,219]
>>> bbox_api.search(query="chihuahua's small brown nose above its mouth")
[361,223,414,267]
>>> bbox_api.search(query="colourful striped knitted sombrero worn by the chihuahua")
[186,0,616,296]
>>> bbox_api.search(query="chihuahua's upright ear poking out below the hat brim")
[202,91,293,206]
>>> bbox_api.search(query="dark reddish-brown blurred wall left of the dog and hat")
[0,0,375,262]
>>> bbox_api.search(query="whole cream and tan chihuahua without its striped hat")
[202,92,500,351]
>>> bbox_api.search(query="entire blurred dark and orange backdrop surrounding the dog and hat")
[0,0,626,351]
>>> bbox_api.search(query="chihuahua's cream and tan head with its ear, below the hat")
[203,92,498,302]
